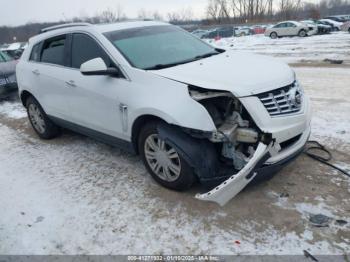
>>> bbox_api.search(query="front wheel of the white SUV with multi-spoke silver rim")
[138,122,195,191]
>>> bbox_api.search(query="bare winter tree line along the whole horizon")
[0,0,350,44]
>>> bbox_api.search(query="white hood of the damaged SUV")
[151,51,295,97]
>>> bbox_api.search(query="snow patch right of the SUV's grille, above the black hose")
[295,68,350,152]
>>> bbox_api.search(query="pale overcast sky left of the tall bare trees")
[0,0,207,26]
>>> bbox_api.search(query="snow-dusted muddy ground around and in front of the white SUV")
[0,34,350,256]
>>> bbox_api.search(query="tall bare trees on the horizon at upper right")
[206,0,350,24]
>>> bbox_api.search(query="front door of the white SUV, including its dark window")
[66,33,130,140]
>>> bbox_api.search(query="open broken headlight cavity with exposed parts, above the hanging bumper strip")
[189,86,266,171]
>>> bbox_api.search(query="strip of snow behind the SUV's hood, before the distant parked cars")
[207,32,350,63]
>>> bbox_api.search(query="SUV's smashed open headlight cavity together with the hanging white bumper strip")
[189,86,279,206]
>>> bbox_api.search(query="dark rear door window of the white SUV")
[41,35,67,66]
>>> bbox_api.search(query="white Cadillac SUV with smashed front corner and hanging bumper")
[17,21,311,205]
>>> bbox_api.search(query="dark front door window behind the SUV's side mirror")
[72,34,111,68]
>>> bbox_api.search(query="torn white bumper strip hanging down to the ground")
[196,142,278,206]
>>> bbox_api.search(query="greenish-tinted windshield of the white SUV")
[105,26,220,70]
